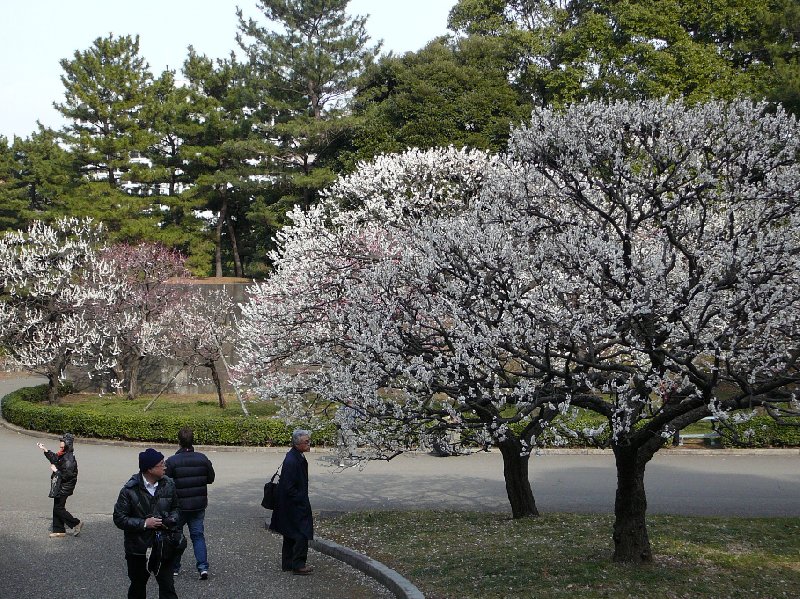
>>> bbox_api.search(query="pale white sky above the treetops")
[0,0,456,141]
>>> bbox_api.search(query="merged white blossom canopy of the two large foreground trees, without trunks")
[239,101,800,458]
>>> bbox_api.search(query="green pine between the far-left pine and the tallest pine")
[177,48,274,277]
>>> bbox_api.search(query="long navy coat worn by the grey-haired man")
[269,447,314,539]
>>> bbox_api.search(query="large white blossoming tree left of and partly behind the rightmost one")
[239,149,558,517]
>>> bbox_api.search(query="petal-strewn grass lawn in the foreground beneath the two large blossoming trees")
[317,511,800,599]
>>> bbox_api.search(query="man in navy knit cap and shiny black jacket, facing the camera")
[114,448,178,599]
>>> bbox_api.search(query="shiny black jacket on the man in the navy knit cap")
[114,472,178,555]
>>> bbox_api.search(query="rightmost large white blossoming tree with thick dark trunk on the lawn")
[504,101,800,562]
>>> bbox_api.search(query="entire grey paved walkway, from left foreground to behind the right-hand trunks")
[0,381,800,599]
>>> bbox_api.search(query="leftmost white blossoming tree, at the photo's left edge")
[0,219,122,403]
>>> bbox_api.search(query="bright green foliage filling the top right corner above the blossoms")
[449,0,800,110]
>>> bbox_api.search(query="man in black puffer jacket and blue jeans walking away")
[167,426,214,580]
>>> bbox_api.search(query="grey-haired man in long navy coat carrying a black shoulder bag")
[269,430,314,575]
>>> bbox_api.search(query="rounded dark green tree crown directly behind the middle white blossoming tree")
[339,36,531,168]
